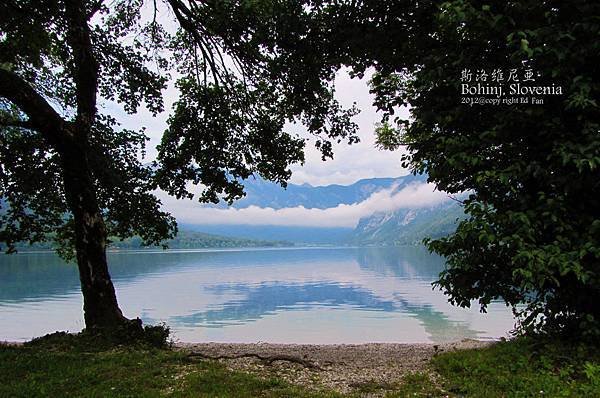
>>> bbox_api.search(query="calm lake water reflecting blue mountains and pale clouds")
[0,247,514,344]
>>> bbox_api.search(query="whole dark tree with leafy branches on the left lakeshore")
[0,0,357,330]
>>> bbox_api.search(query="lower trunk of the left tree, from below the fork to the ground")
[61,140,128,330]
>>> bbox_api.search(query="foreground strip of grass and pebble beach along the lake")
[0,335,600,398]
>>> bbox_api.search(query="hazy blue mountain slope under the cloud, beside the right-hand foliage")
[349,201,465,245]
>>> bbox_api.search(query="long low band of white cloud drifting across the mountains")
[163,183,448,228]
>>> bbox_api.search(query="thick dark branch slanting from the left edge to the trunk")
[0,68,69,148]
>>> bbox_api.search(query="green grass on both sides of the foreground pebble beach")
[0,335,600,398]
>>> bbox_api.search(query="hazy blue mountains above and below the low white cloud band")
[188,175,464,245]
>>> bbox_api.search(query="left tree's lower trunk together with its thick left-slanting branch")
[0,69,132,329]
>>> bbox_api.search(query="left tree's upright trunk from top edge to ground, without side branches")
[59,0,135,329]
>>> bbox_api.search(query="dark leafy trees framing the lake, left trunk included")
[0,0,600,334]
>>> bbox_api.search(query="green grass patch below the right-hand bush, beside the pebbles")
[432,338,600,398]
